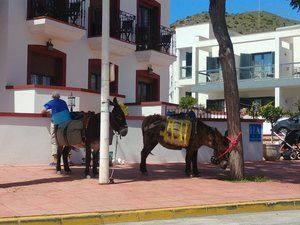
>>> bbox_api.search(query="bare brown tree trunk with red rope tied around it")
[209,0,244,180]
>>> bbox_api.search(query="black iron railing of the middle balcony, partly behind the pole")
[89,7,135,43]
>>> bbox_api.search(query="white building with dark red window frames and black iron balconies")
[0,0,176,113]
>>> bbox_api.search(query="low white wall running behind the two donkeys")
[0,116,262,165]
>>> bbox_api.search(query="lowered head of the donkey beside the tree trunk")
[207,128,229,169]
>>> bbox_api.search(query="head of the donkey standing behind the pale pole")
[110,98,128,137]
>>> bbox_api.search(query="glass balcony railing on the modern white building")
[198,65,275,83]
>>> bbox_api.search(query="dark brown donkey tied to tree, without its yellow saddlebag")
[140,115,229,176]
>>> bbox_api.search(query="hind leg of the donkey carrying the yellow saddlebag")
[140,135,158,175]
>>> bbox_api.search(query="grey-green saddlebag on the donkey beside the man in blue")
[56,120,83,146]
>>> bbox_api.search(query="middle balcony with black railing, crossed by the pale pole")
[88,7,136,57]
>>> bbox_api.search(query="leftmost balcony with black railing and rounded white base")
[27,0,86,41]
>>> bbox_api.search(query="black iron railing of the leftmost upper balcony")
[27,0,85,27]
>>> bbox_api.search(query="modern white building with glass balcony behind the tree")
[169,23,300,110]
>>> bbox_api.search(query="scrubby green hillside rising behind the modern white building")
[171,11,300,34]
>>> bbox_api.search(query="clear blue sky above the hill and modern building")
[170,0,300,23]
